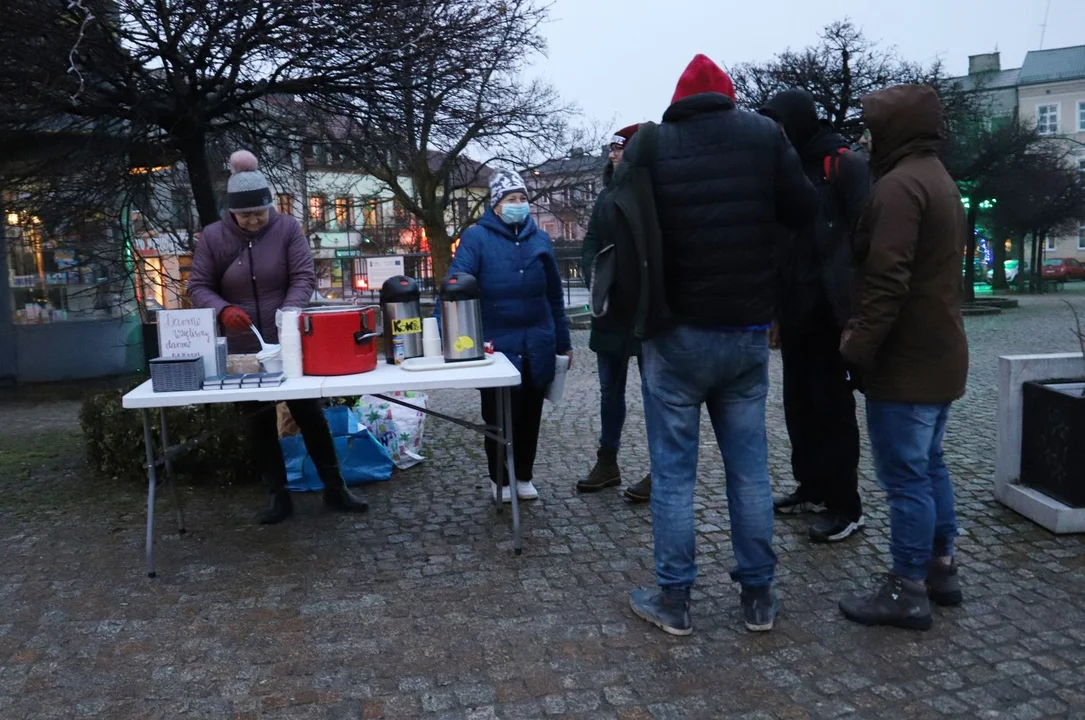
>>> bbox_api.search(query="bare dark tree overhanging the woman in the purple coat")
[0,0,462,224]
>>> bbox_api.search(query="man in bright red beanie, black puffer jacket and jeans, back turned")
[626,55,818,635]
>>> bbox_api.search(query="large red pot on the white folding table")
[301,305,381,375]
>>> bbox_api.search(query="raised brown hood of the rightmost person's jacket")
[863,85,944,177]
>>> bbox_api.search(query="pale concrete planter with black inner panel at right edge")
[995,352,1085,533]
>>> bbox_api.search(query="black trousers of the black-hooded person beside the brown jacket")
[780,308,863,520]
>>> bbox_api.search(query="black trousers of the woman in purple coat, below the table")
[238,399,343,492]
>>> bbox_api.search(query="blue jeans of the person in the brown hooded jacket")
[867,400,957,582]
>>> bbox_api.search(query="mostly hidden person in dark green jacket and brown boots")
[576,125,652,502]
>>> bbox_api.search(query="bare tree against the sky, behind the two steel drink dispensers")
[314,0,598,277]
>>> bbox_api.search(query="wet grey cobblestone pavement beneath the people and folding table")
[0,294,1085,720]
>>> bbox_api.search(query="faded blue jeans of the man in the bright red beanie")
[644,326,776,588]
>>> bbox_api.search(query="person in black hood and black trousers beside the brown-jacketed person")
[760,90,871,542]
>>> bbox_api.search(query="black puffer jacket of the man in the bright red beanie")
[634,92,818,327]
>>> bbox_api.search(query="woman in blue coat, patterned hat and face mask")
[449,170,573,502]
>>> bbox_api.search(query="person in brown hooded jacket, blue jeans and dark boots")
[840,85,968,630]
